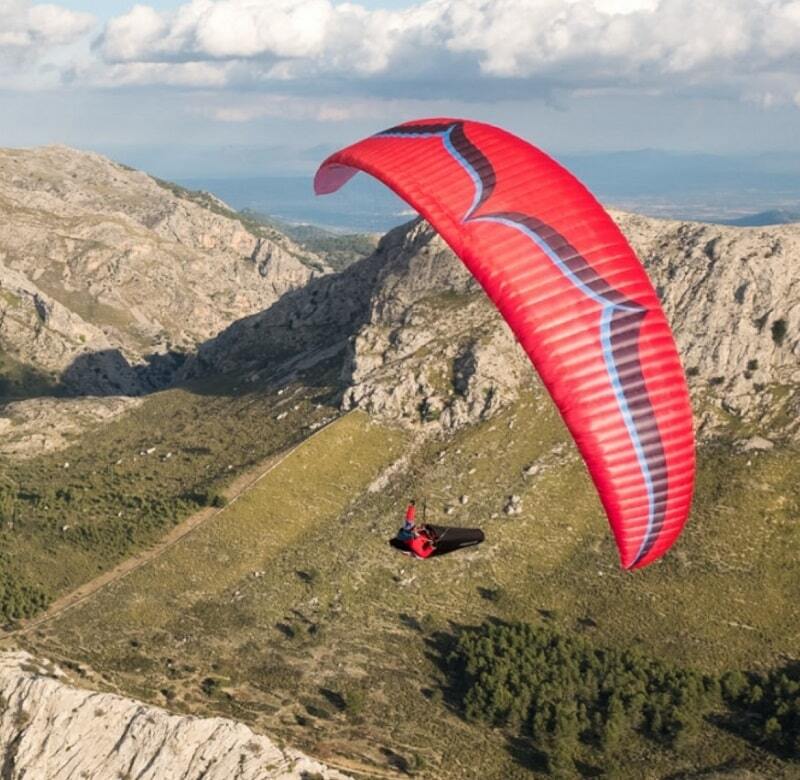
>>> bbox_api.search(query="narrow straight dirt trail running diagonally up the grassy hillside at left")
[0,416,341,640]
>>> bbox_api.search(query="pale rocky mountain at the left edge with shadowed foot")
[0,146,330,395]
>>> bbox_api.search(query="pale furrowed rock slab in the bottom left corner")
[0,652,346,780]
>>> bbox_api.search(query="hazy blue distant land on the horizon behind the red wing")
[179,149,800,233]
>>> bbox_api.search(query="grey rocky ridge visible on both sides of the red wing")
[189,213,800,442]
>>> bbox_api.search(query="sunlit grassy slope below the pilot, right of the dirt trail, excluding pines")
[20,392,800,778]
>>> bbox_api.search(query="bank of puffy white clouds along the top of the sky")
[0,0,800,112]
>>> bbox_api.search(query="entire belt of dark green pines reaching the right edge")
[448,622,800,777]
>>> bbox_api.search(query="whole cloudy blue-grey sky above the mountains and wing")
[0,0,800,184]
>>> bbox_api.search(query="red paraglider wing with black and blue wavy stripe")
[314,119,695,568]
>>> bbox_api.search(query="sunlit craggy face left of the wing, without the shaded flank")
[342,222,531,428]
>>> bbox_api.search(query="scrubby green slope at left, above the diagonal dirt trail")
[0,372,334,620]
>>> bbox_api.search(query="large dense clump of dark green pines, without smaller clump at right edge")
[450,623,718,776]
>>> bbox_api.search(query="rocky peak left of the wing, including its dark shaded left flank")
[189,221,531,429]
